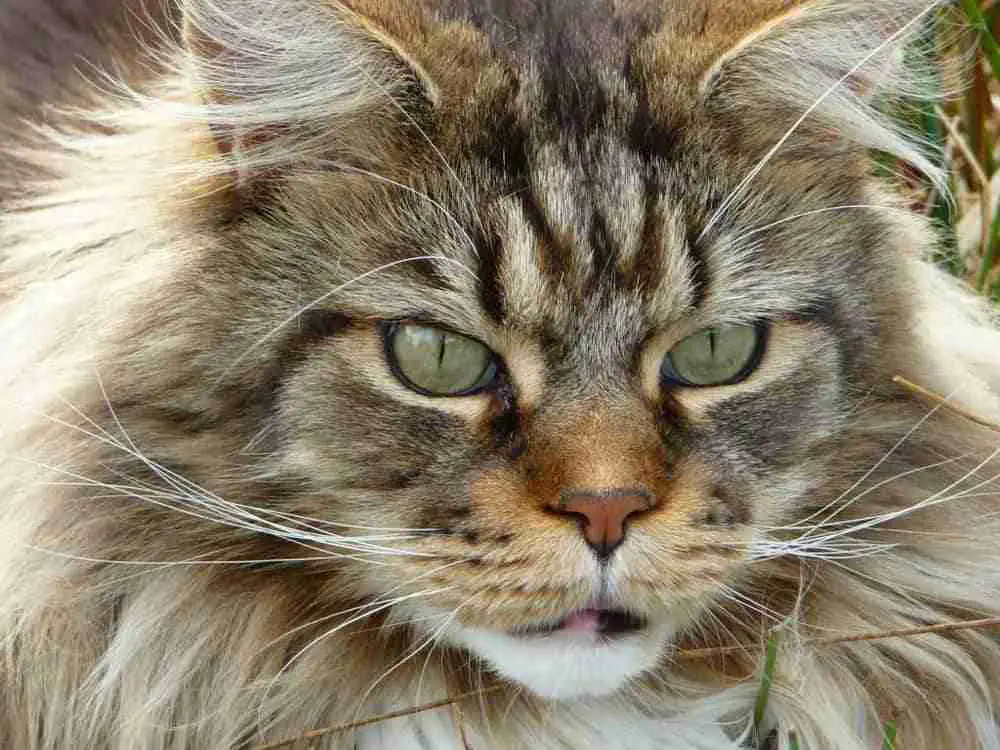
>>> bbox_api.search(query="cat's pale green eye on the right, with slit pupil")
[662,325,767,386]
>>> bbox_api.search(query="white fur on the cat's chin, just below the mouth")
[448,625,672,700]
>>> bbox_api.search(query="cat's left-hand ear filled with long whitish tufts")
[182,0,438,183]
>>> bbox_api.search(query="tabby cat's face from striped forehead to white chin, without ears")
[143,1,920,697]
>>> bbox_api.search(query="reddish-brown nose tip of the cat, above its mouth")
[549,488,655,560]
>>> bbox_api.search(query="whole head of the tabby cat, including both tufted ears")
[68,0,933,697]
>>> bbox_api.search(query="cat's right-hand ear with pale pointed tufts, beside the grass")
[700,0,947,182]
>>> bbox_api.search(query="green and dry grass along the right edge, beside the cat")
[749,0,1000,750]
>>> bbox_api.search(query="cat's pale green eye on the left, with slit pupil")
[386,323,498,396]
